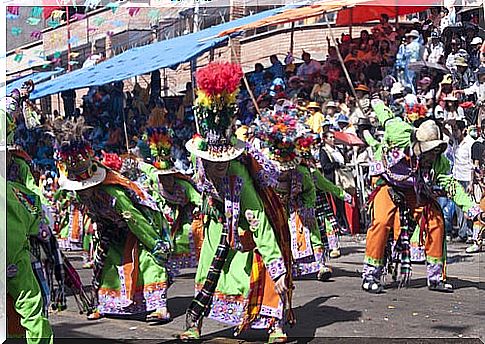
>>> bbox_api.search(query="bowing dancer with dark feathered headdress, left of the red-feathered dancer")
[51,118,170,321]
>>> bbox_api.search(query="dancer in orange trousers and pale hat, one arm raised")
[362,99,480,293]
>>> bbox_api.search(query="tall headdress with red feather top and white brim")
[186,62,245,161]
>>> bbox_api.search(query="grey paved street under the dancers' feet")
[50,237,485,344]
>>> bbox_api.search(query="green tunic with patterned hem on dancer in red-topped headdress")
[195,160,286,327]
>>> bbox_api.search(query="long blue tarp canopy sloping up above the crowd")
[31,2,302,99]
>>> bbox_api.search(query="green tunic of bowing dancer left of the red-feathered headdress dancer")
[88,185,168,314]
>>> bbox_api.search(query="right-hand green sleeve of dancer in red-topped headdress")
[229,161,286,280]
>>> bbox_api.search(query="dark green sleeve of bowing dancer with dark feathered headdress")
[104,186,160,251]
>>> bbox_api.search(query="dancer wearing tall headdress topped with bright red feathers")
[180,63,290,342]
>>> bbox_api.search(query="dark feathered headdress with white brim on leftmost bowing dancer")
[47,117,106,191]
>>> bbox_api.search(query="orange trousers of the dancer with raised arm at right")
[364,185,445,266]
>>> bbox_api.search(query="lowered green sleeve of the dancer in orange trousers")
[433,155,475,212]
